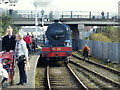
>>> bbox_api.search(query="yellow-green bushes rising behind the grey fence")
[89,26,120,42]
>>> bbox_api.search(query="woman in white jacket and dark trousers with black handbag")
[15,34,29,85]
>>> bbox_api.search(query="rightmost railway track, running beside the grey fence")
[73,55,120,84]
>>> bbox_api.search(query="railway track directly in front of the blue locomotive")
[36,61,88,90]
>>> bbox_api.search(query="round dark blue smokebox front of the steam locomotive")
[46,22,67,46]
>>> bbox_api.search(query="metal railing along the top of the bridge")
[11,10,119,19]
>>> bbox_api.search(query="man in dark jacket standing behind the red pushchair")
[2,26,16,52]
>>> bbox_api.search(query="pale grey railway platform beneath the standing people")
[7,48,40,90]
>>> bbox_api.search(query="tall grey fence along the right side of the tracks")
[73,40,120,62]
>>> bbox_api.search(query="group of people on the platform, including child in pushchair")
[0,26,37,85]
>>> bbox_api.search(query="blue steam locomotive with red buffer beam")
[41,20,72,62]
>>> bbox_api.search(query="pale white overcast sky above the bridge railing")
[11,0,120,12]
